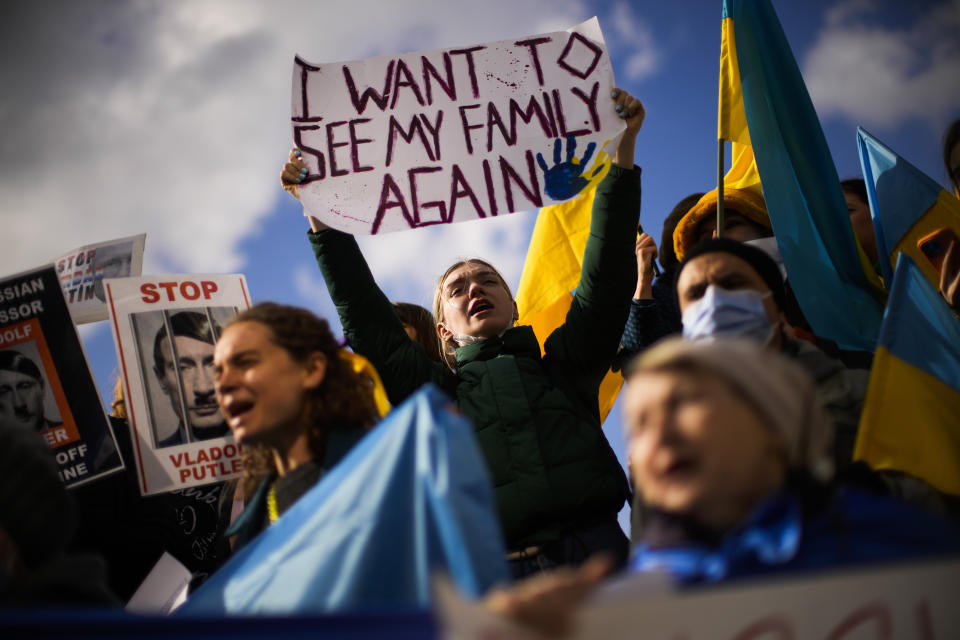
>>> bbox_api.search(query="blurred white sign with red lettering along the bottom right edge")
[435,557,960,640]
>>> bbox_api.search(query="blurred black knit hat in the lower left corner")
[0,427,76,569]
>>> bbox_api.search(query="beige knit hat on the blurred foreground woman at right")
[627,338,833,481]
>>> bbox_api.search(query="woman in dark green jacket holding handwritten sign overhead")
[281,89,645,577]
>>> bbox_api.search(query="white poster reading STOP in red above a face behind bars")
[104,275,250,495]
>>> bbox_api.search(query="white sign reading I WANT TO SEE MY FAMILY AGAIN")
[291,18,625,234]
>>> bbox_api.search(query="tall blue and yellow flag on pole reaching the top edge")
[718,0,884,350]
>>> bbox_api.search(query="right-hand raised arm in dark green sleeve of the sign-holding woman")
[545,89,645,396]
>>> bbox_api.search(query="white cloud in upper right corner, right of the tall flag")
[803,0,960,130]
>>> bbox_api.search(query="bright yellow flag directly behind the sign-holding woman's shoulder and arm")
[517,180,623,422]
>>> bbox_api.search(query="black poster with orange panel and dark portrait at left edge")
[0,265,123,487]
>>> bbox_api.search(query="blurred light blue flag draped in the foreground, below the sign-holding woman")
[178,385,508,616]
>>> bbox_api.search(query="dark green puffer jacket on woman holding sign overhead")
[309,167,640,549]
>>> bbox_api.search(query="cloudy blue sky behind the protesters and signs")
[0,0,960,528]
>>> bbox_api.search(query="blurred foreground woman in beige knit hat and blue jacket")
[487,339,960,633]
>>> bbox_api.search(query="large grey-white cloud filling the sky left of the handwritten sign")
[0,0,589,273]
